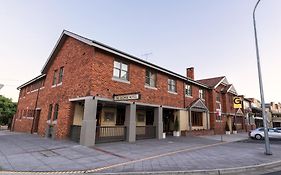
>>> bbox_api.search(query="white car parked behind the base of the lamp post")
[249,128,281,140]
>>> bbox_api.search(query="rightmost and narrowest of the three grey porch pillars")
[153,107,163,139]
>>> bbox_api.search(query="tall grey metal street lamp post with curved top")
[253,0,272,155]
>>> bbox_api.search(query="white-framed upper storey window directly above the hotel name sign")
[113,60,129,80]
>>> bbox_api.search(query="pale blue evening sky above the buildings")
[0,0,281,102]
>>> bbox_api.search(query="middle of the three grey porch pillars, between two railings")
[125,104,136,142]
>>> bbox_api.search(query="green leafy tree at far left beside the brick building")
[0,95,17,125]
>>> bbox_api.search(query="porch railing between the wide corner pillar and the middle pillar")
[96,126,126,143]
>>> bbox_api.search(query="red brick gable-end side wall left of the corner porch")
[14,37,94,138]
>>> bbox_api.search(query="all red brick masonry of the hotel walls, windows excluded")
[13,30,245,139]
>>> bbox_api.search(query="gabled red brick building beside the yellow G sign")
[198,76,245,134]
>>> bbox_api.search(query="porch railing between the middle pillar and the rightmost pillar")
[136,125,156,140]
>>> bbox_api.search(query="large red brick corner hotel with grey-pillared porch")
[12,31,243,146]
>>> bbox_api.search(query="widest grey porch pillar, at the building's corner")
[80,97,98,146]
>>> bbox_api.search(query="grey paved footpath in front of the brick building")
[0,131,281,174]
